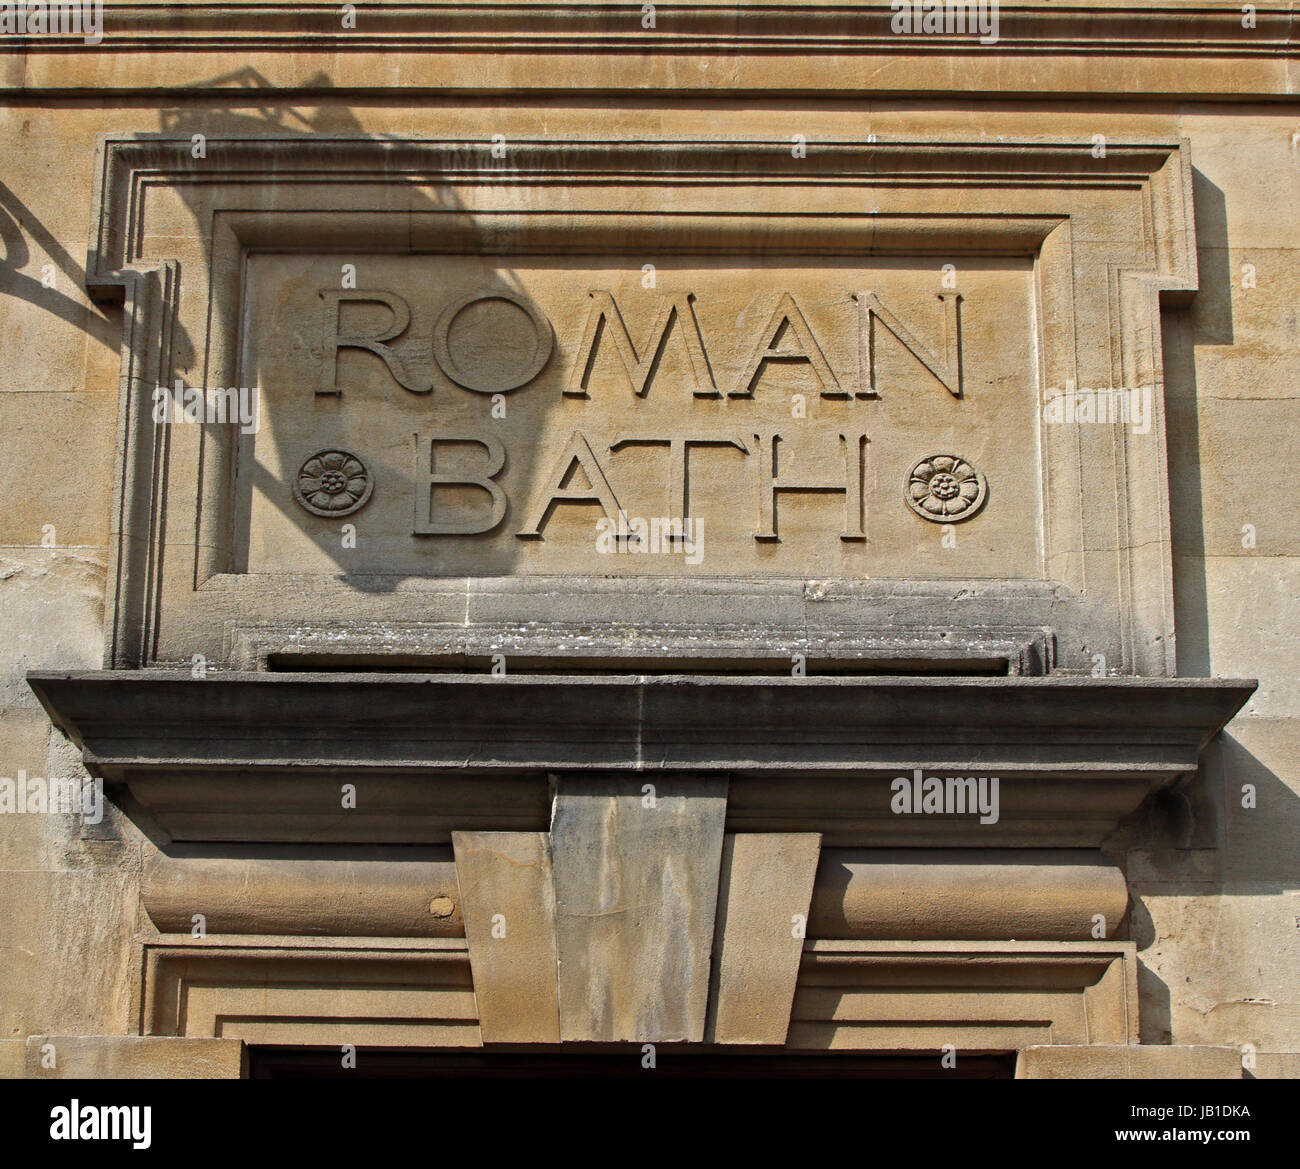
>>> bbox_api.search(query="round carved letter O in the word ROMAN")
[433,290,555,394]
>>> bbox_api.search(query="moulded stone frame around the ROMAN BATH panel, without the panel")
[87,135,1196,676]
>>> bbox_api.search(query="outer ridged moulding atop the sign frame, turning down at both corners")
[86,133,1196,299]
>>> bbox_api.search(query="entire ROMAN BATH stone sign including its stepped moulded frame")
[88,137,1196,675]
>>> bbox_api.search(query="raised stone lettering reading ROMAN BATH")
[317,289,961,541]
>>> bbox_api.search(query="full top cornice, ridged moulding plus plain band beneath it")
[0,0,1300,98]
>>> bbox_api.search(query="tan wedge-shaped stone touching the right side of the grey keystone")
[705,832,822,1044]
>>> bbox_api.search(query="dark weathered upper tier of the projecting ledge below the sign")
[29,670,1256,779]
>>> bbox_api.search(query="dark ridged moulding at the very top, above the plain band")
[13,0,1297,57]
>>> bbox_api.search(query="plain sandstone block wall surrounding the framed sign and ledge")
[0,6,1300,1075]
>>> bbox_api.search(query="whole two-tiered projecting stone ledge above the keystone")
[29,670,1256,848]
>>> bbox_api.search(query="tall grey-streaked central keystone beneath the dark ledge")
[551,775,727,1043]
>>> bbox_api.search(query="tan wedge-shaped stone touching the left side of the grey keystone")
[451,832,560,1043]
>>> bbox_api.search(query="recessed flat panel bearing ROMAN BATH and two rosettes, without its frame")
[241,255,1040,577]
